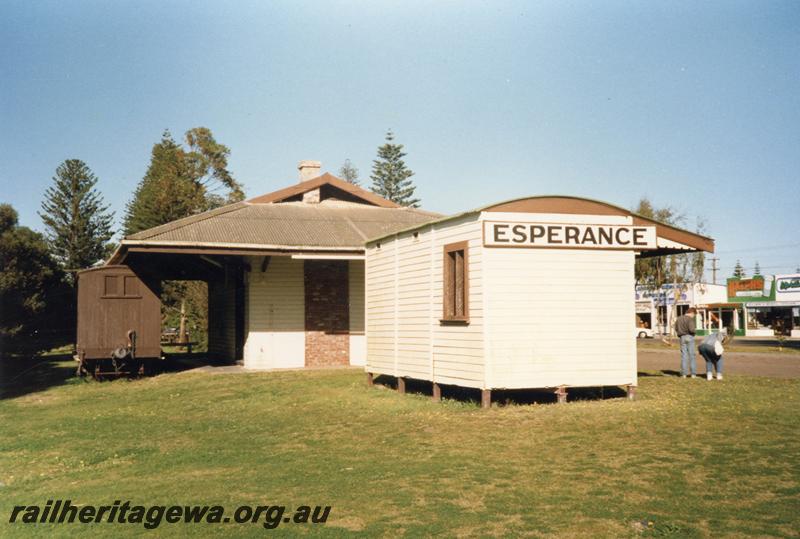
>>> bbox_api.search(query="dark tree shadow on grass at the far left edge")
[0,354,77,399]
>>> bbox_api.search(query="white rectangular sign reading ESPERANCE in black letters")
[483,221,656,251]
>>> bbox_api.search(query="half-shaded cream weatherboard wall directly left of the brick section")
[244,256,306,369]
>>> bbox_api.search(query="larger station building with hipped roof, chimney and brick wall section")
[103,161,440,369]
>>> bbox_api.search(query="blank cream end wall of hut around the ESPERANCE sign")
[483,212,636,388]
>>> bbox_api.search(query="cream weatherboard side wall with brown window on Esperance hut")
[366,215,485,387]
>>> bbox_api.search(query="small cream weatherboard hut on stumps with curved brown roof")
[366,197,714,406]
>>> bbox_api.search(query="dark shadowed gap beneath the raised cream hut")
[375,375,627,406]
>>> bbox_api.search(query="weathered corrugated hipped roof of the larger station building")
[126,200,438,249]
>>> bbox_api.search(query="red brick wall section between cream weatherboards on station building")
[303,260,350,367]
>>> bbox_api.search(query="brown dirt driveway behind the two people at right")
[638,349,800,378]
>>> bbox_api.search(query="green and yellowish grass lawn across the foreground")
[0,363,800,537]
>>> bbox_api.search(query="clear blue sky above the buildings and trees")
[0,0,800,276]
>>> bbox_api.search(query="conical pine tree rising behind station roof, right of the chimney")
[370,129,420,208]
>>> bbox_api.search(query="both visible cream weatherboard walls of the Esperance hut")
[366,212,636,389]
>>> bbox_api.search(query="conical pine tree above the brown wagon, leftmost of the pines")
[39,159,114,270]
